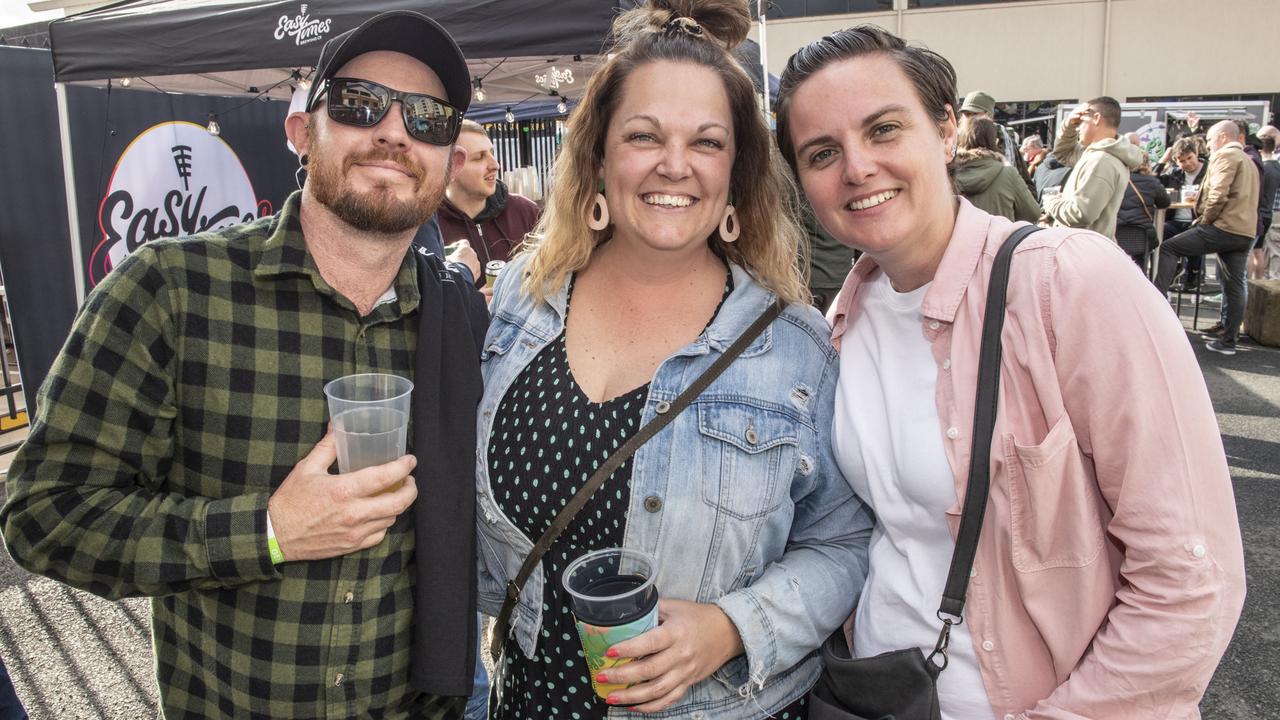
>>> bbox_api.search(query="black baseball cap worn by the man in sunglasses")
[307,10,471,113]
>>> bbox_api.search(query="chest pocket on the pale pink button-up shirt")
[1004,413,1106,573]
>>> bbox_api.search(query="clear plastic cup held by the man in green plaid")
[324,373,413,473]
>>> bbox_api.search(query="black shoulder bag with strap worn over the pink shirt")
[809,225,1039,720]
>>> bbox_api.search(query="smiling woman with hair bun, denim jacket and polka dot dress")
[477,0,873,720]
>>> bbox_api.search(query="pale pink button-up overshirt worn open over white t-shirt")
[831,200,1244,720]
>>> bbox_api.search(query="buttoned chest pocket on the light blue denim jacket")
[698,401,800,520]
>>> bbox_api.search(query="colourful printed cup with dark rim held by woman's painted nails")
[563,547,658,698]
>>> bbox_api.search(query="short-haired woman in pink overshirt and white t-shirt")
[777,26,1244,719]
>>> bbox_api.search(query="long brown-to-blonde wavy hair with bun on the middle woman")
[524,0,809,302]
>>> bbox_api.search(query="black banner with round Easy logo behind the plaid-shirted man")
[68,87,297,291]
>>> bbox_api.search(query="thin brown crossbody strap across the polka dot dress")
[489,294,783,660]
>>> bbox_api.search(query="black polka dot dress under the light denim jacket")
[489,274,804,720]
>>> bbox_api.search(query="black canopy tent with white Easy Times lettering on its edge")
[49,0,632,304]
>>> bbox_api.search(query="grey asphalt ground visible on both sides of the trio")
[0,299,1280,720]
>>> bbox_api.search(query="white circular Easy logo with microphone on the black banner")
[88,122,271,286]
